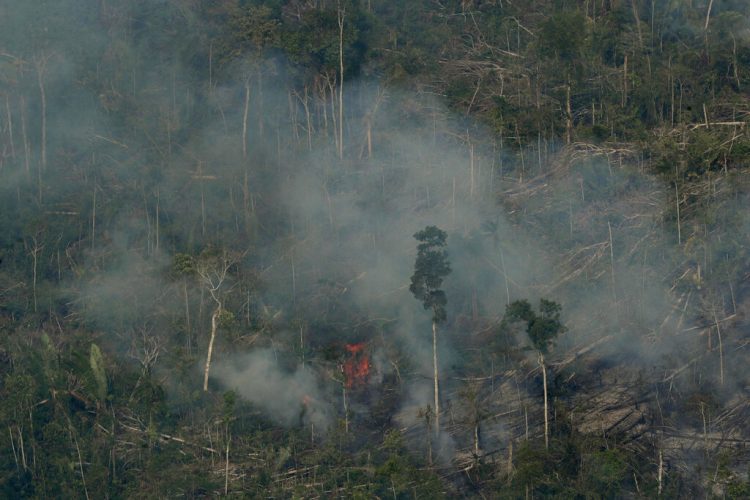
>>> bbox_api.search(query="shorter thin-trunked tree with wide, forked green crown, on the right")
[503,299,566,449]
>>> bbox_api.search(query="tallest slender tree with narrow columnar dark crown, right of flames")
[409,226,451,433]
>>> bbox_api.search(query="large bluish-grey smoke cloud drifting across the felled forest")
[0,2,747,464]
